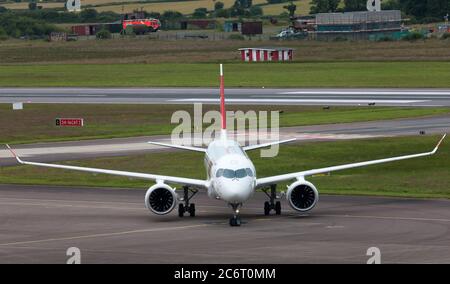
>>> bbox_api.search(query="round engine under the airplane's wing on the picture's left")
[145,183,178,215]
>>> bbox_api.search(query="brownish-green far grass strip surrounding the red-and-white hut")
[0,38,450,64]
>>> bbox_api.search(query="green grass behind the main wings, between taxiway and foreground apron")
[0,136,450,198]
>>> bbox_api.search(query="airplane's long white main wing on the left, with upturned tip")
[6,145,209,188]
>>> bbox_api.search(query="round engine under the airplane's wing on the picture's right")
[286,180,319,212]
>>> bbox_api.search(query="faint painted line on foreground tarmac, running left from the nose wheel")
[0,224,208,246]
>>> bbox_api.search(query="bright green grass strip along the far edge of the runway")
[0,62,450,88]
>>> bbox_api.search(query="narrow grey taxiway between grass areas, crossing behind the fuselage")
[0,116,450,166]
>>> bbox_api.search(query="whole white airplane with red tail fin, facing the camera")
[6,65,446,226]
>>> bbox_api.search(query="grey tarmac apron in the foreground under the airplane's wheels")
[0,185,450,264]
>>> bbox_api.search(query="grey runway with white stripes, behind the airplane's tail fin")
[0,87,450,106]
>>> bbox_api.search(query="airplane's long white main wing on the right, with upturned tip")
[256,134,447,187]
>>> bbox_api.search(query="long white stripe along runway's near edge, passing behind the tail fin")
[170,98,428,104]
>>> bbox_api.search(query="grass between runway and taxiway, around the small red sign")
[0,104,450,144]
